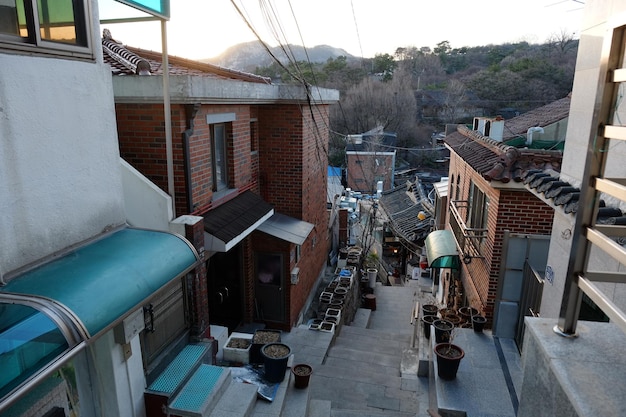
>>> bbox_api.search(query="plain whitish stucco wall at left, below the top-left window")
[0,53,125,274]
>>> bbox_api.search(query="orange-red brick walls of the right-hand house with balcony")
[450,154,554,321]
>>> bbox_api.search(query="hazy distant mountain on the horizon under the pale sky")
[201,41,356,72]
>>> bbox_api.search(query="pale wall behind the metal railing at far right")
[540,0,626,318]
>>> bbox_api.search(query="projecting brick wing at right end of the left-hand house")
[259,105,330,325]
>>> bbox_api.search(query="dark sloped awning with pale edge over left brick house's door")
[204,191,274,252]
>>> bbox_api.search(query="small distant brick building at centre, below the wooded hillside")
[346,128,397,194]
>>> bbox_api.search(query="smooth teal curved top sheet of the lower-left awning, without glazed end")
[0,228,197,337]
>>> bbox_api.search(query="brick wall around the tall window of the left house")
[116,104,258,216]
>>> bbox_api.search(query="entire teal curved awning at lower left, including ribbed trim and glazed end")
[0,228,198,405]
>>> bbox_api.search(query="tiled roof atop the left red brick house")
[102,30,271,84]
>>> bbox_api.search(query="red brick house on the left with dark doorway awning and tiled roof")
[102,31,338,331]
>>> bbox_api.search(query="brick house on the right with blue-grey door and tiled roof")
[440,97,570,337]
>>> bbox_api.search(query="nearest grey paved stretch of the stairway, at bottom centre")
[308,314,420,417]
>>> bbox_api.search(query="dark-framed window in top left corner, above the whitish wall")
[0,0,91,57]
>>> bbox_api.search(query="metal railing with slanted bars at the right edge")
[554,21,626,337]
